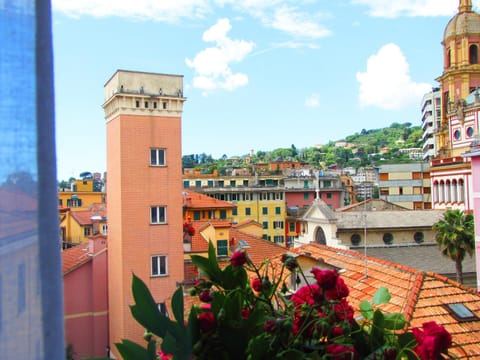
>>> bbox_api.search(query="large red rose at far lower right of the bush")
[412,321,452,360]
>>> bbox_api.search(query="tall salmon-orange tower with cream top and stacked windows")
[103,70,186,356]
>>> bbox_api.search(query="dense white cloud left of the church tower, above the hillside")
[357,43,432,110]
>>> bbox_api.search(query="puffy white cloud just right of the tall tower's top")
[185,19,255,92]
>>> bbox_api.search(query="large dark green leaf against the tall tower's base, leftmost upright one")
[130,274,172,338]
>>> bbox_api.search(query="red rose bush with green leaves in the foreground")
[116,243,451,360]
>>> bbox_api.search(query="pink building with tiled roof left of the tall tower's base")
[62,235,109,359]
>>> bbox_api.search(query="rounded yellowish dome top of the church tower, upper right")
[443,0,480,41]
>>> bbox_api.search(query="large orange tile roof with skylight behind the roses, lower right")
[284,244,480,359]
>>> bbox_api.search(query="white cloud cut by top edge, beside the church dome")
[352,0,458,18]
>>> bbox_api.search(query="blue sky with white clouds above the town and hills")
[52,0,480,179]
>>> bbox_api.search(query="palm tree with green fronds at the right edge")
[432,210,475,283]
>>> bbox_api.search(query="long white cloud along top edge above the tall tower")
[52,0,211,22]
